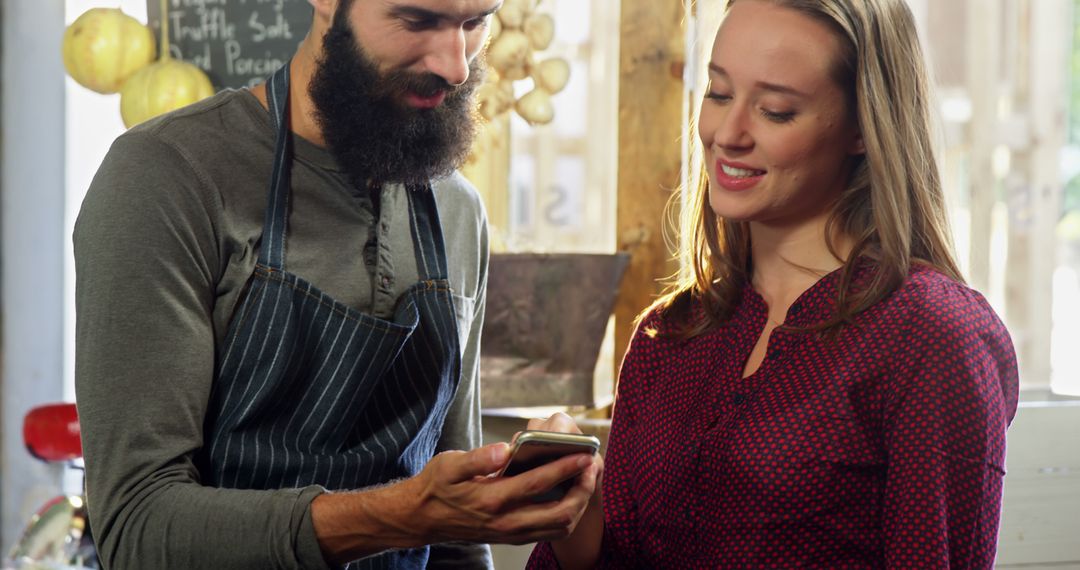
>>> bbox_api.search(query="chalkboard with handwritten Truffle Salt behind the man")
[147,0,311,90]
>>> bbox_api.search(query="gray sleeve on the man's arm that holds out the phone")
[73,130,326,570]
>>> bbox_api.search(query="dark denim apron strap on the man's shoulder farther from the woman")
[259,62,293,270]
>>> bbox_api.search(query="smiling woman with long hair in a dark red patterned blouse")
[530,0,1017,570]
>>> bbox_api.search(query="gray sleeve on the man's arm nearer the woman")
[428,182,494,569]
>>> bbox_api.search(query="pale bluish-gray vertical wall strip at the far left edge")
[0,0,65,551]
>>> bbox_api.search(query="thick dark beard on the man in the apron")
[309,8,484,188]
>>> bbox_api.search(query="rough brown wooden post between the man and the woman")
[615,0,686,366]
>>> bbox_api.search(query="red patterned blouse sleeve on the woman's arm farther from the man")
[882,284,1018,569]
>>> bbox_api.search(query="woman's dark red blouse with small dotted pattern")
[529,266,1017,569]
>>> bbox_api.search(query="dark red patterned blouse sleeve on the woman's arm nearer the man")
[527,313,658,570]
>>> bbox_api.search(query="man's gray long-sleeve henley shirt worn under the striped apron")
[75,91,490,570]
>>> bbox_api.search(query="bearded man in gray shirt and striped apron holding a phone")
[75,0,602,570]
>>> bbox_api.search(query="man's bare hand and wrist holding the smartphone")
[312,413,604,564]
